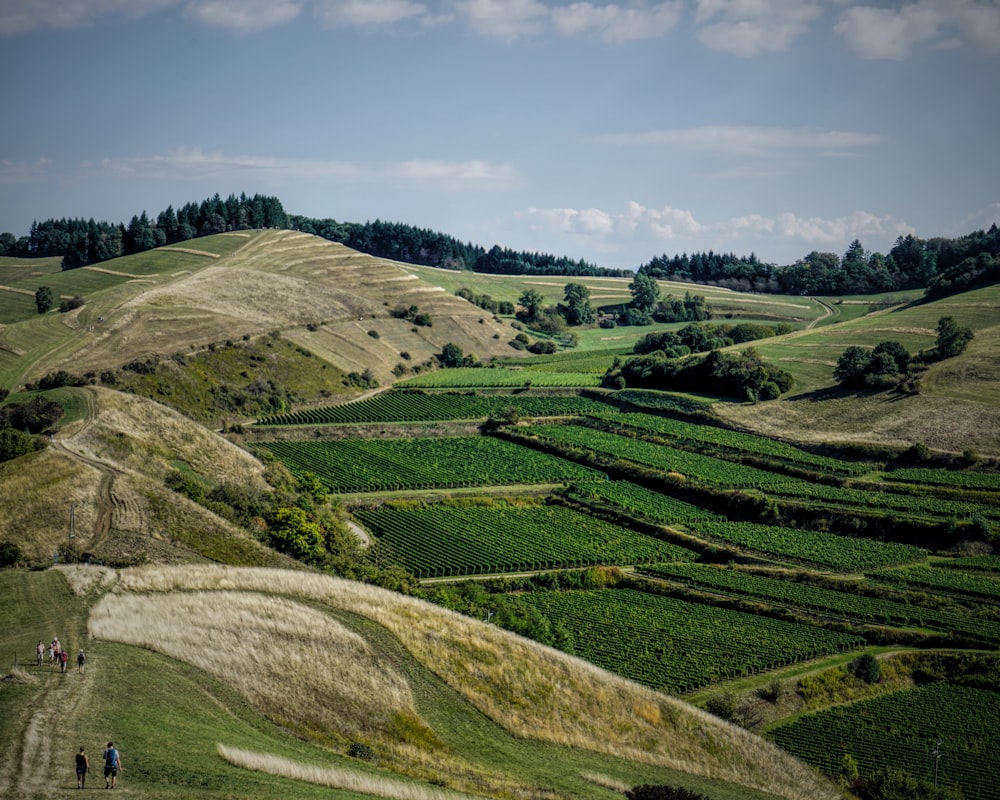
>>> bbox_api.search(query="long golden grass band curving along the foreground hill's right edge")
[109,567,837,800]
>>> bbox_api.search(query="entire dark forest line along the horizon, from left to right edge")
[0,194,1000,297]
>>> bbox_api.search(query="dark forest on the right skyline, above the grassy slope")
[638,223,1000,297]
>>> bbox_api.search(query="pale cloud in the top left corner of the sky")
[0,0,179,36]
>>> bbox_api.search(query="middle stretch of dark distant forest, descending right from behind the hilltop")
[288,214,635,278]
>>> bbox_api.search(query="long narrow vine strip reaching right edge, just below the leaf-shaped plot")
[643,564,1000,643]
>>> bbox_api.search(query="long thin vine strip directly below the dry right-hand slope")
[594,408,871,475]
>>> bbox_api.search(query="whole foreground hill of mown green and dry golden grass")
[0,568,836,800]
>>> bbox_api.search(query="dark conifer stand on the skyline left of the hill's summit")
[0,194,288,270]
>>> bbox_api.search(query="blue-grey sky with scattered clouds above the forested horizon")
[0,0,1000,268]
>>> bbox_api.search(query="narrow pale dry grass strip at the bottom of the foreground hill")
[219,744,470,800]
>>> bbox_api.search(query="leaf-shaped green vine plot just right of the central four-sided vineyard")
[691,521,927,572]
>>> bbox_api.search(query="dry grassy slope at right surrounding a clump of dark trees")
[716,285,1000,455]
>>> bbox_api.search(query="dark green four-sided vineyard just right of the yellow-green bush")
[356,505,694,578]
